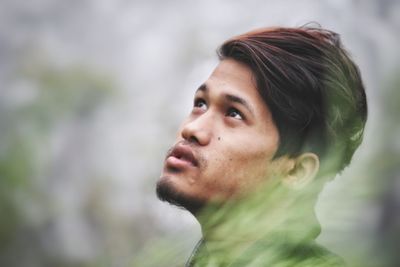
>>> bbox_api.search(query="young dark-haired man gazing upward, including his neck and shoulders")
[157,27,367,266]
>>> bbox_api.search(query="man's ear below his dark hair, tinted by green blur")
[282,153,319,190]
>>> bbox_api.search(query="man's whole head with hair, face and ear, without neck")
[157,27,367,216]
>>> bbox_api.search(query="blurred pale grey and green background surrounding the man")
[0,0,400,267]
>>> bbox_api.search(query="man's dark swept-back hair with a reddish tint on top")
[217,26,367,173]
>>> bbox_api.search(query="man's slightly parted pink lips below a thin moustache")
[166,144,199,170]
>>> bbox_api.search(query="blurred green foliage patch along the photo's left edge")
[0,61,114,266]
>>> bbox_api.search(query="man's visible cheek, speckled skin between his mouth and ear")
[192,130,277,198]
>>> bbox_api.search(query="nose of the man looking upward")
[181,113,213,146]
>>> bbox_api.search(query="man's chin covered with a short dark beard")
[156,176,206,215]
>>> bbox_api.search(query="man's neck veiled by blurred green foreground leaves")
[196,184,320,250]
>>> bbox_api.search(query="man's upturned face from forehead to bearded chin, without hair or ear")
[157,59,279,214]
